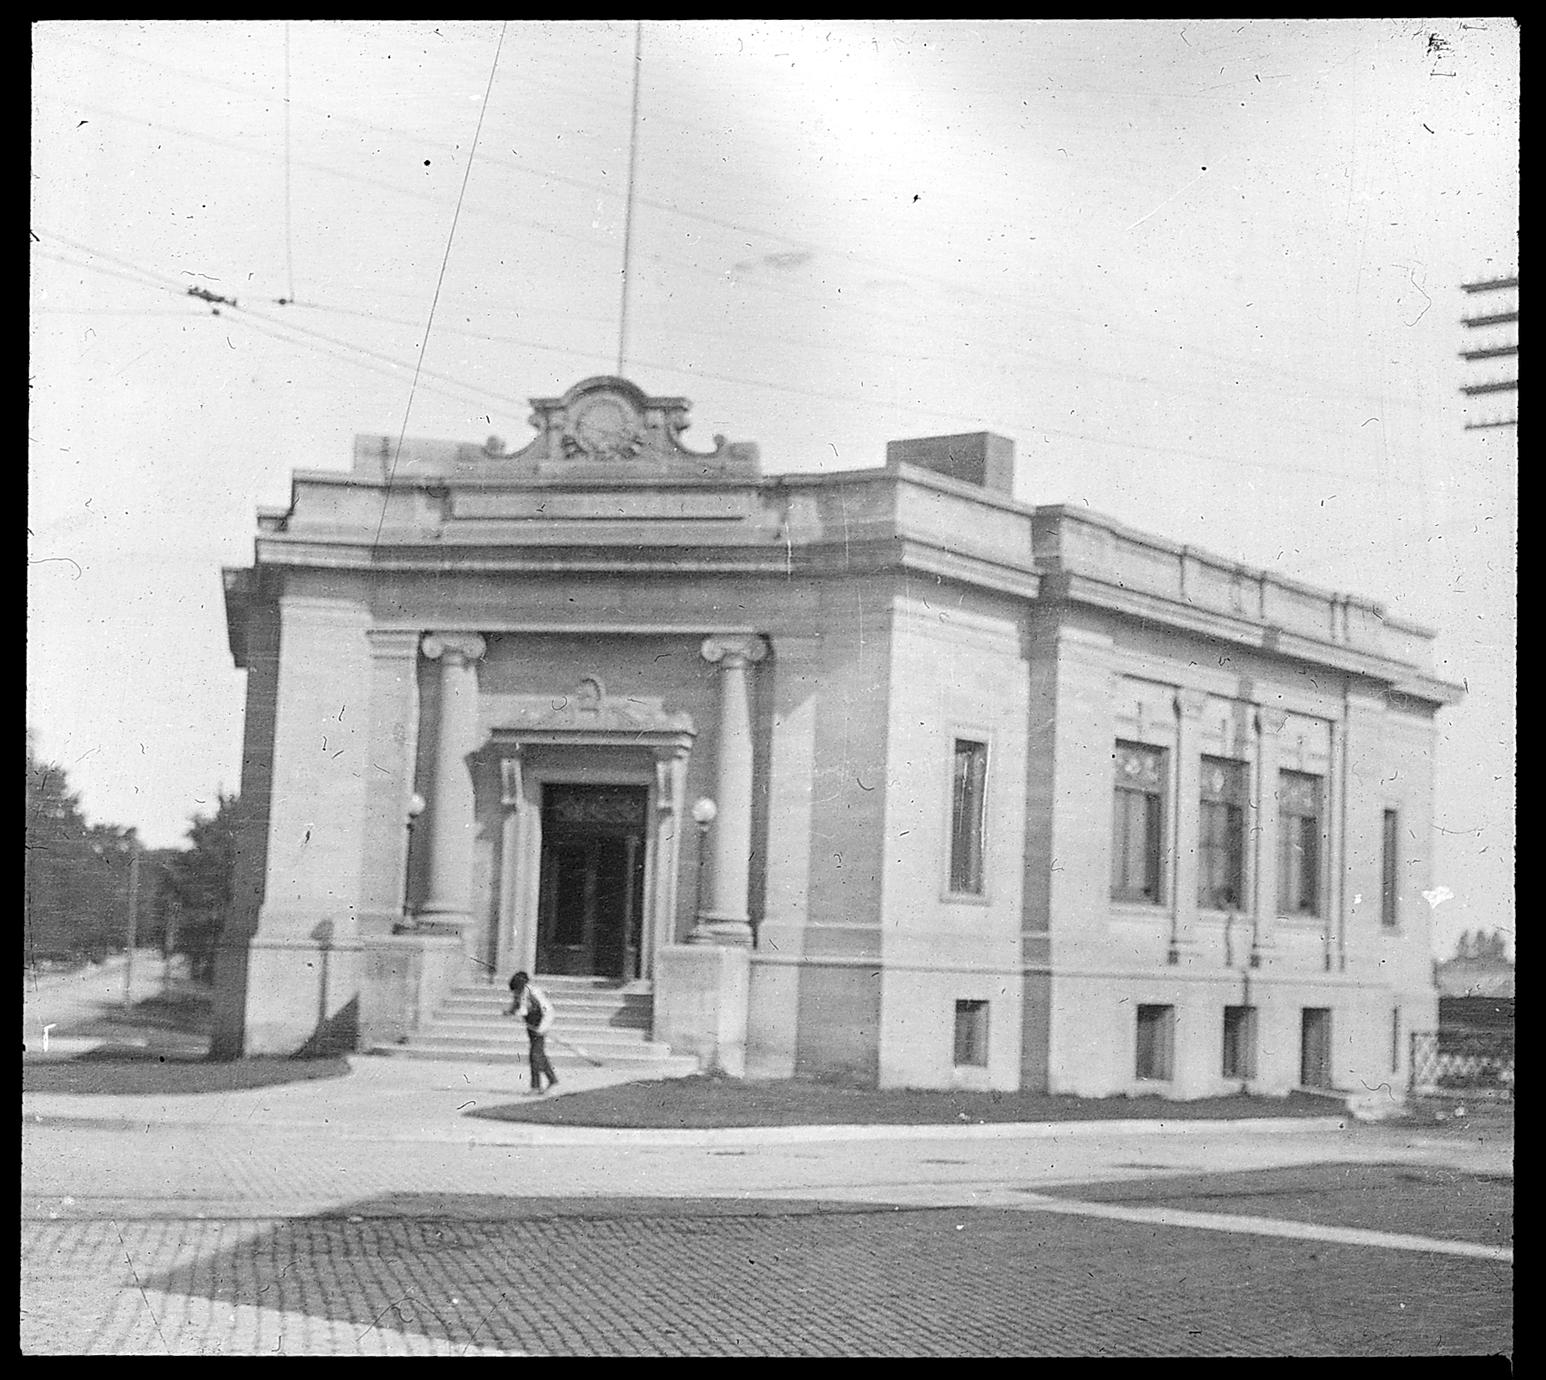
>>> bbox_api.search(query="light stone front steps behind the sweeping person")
[373,975,697,1077]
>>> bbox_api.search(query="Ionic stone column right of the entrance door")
[688,635,768,944]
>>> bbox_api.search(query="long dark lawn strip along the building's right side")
[470,1076,1345,1130]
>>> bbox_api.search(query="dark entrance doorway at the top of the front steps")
[536,782,649,981]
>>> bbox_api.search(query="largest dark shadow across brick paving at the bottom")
[132,1195,1512,1357]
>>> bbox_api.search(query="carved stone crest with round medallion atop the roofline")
[485,377,759,481]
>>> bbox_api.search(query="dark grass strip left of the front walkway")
[22,1045,349,1096]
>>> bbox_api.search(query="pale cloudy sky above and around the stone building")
[26,19,1520,950]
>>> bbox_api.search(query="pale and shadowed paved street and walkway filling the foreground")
[22,958,1514,1357]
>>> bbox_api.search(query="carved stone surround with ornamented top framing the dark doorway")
[485,675,696,980]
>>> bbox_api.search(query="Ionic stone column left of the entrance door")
[419,632,487,932]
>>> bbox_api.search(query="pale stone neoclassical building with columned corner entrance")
[216,370,1458,1097]
